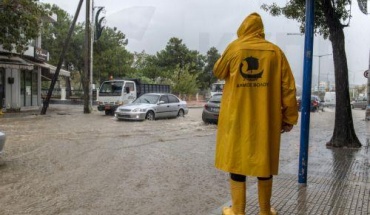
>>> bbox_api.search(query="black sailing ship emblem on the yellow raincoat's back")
[239,56,263,81]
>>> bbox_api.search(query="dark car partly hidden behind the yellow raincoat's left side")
[202,94,222,124]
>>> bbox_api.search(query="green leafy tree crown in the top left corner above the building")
[0,0,48,54]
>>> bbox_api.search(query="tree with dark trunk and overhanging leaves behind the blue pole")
[262,0,361,148]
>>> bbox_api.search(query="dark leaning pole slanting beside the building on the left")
[40,0,83,115]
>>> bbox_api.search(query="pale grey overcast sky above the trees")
[40,0,370,86]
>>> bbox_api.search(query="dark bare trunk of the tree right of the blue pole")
[323,0,361,148]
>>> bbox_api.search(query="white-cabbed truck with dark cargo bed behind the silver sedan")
[97,79,170,115]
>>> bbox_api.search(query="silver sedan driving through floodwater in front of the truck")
[115,93,189,120]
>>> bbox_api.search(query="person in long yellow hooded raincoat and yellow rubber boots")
[213,13,298,215]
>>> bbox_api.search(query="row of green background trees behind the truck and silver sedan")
[37,5,220,94]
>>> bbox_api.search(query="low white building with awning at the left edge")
[0,14,70,110]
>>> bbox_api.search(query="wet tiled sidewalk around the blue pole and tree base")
[211,111,370,215]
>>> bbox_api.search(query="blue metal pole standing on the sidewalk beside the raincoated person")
[298,0,314,185]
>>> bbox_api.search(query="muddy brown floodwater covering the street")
[0,106,367,215]
